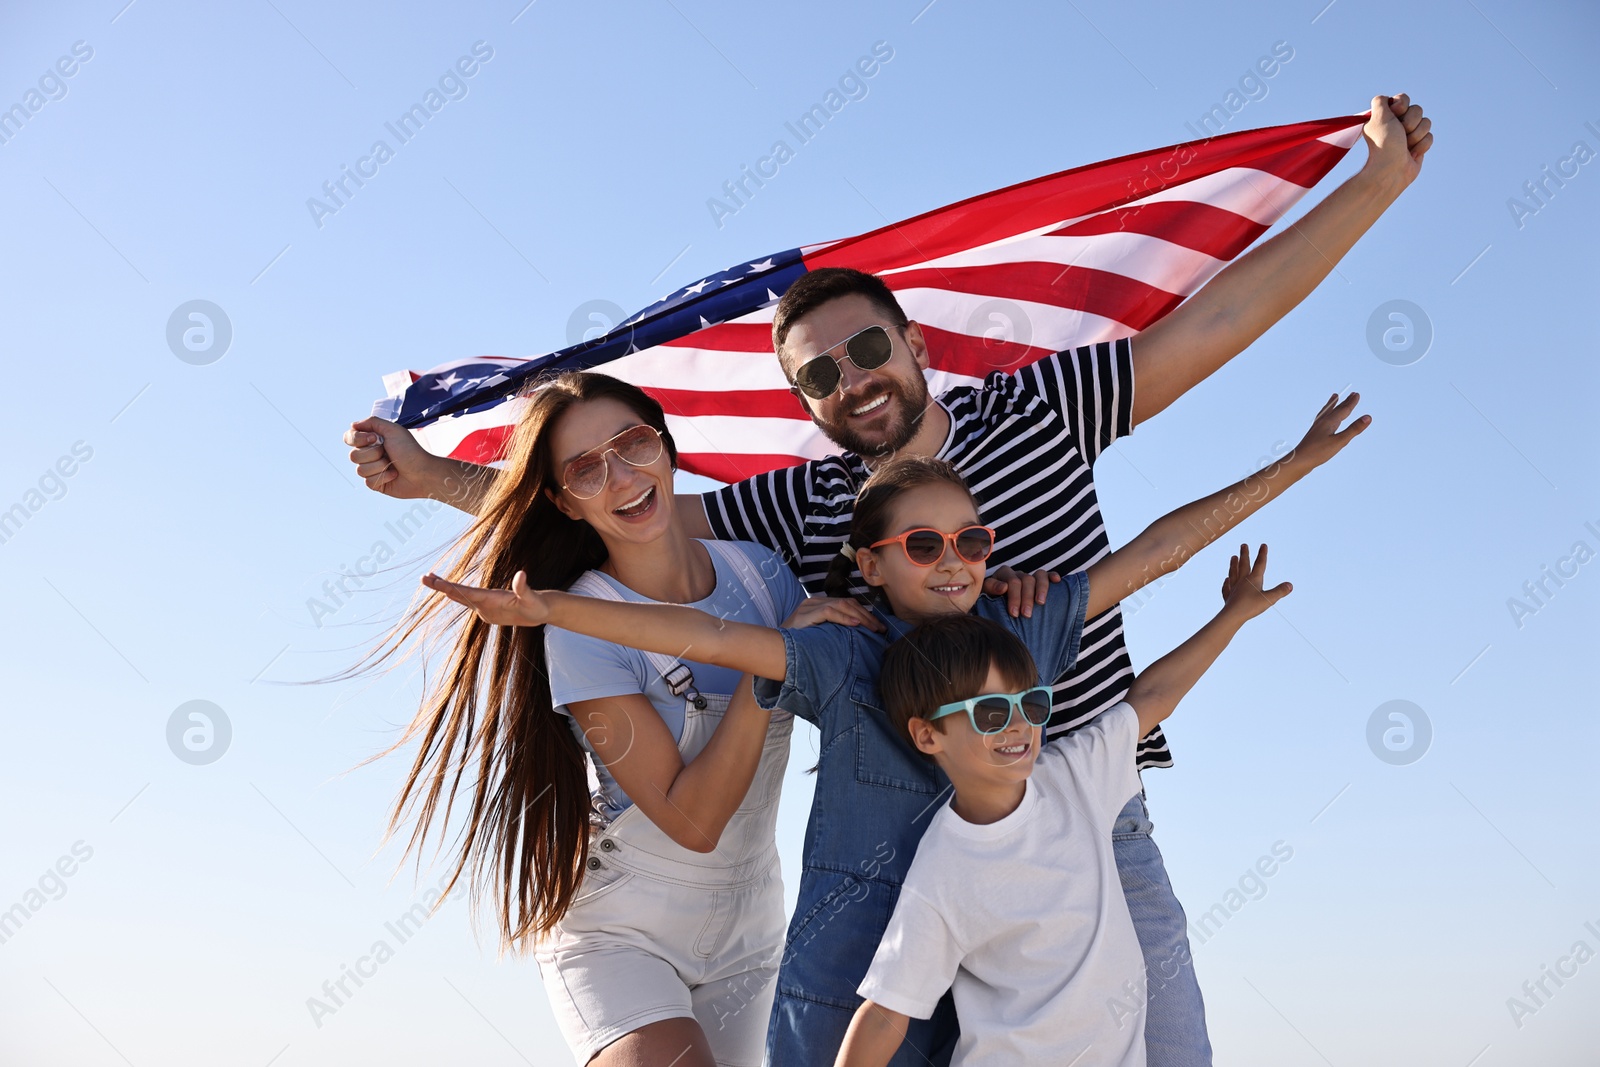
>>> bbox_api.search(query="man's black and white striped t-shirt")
[704,338,1171,769]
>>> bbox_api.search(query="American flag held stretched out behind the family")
[373,115,1366,482]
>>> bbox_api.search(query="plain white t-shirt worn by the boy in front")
[856,701,1144,1067]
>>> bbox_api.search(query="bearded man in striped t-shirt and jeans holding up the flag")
[344,94,1434,1067]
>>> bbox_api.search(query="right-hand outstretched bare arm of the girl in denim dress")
[1085,392,1373,619]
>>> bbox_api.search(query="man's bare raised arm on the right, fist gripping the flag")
[1133,93,1434,426]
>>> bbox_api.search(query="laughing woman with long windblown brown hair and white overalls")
[369,373,875,1067]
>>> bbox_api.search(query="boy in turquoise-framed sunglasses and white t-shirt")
[837,545,1290,1067]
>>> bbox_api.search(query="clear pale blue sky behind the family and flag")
[0,0,1600,1067]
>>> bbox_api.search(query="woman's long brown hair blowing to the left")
[373,373,677,950]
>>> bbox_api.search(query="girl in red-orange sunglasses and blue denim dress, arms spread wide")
[422,397,1370,1067]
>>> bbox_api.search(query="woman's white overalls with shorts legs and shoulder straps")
[534,541,794,1067]
